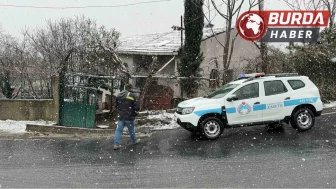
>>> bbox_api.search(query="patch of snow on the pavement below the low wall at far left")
[0,120,55,133]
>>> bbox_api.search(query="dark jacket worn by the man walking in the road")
[115,90,140,120]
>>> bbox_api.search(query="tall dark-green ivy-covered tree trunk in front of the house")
[179,0,204,96]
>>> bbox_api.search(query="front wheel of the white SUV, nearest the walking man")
[200,117,224,140]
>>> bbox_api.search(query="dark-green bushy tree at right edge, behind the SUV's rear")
[291,28,336,101]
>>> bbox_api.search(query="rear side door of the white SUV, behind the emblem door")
[262,80,290,121]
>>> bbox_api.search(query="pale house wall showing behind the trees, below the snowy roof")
[119,29,260,98]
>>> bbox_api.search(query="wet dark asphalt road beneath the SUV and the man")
[0,111,336,189]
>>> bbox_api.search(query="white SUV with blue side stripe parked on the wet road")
[175,73,323,139]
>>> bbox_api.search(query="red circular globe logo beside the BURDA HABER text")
[236,11,266,41]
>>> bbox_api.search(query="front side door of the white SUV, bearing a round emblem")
[225,82,262,125]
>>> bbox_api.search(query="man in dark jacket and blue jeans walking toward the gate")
[114,84,140,150]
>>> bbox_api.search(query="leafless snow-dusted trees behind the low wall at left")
[0,16,129,98]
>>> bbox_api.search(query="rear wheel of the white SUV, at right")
[291,108,315,131]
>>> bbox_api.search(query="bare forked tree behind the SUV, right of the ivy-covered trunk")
[205,0,258,83]
